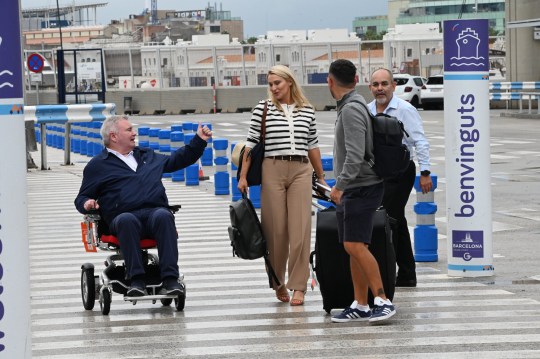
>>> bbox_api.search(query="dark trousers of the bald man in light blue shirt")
[382,161,416,281]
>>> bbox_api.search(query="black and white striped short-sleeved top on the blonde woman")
[246,100,319,157]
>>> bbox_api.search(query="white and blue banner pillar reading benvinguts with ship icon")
[444,20,494,277]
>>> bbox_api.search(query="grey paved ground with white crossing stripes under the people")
[27,111,540,359]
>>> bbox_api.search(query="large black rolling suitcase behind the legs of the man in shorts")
[310,207,396,313]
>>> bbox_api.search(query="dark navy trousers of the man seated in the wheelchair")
[110,208,178,279]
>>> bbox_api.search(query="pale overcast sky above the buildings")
[21,0,387,38]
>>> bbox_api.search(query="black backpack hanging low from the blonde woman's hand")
[228,194,281,288]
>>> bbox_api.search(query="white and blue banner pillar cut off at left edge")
[0,0,32,359]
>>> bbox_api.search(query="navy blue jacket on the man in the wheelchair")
[75,135,206,223]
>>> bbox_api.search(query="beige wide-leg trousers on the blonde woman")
[261,158,313,291]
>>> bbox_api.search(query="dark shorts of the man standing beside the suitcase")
[336,182,384,244]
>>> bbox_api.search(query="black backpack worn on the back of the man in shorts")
[355,101,411,179]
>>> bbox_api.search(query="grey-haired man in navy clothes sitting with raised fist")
[75,116,212,316]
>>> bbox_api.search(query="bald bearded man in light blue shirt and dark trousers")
[368,69,433,287]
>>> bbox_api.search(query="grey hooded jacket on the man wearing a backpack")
[334,90,382,191]
